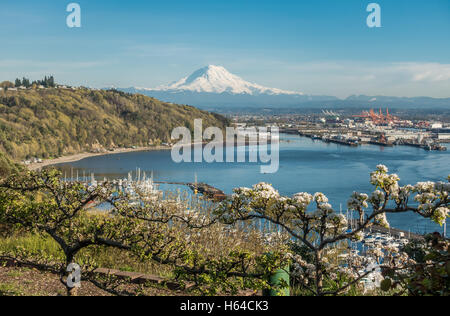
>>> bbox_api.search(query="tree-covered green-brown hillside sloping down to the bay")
[0,88,226,161]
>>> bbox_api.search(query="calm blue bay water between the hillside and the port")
[56,135,450,232]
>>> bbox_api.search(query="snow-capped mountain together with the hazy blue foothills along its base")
[118,65,450,112]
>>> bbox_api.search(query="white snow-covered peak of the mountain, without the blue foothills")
[149,65,303,95]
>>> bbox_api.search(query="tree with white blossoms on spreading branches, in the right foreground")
[217,165,450,295]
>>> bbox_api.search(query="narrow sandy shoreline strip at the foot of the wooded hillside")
[26,146,172,171]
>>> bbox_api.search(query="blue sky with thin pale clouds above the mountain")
[0,0,450,97]
